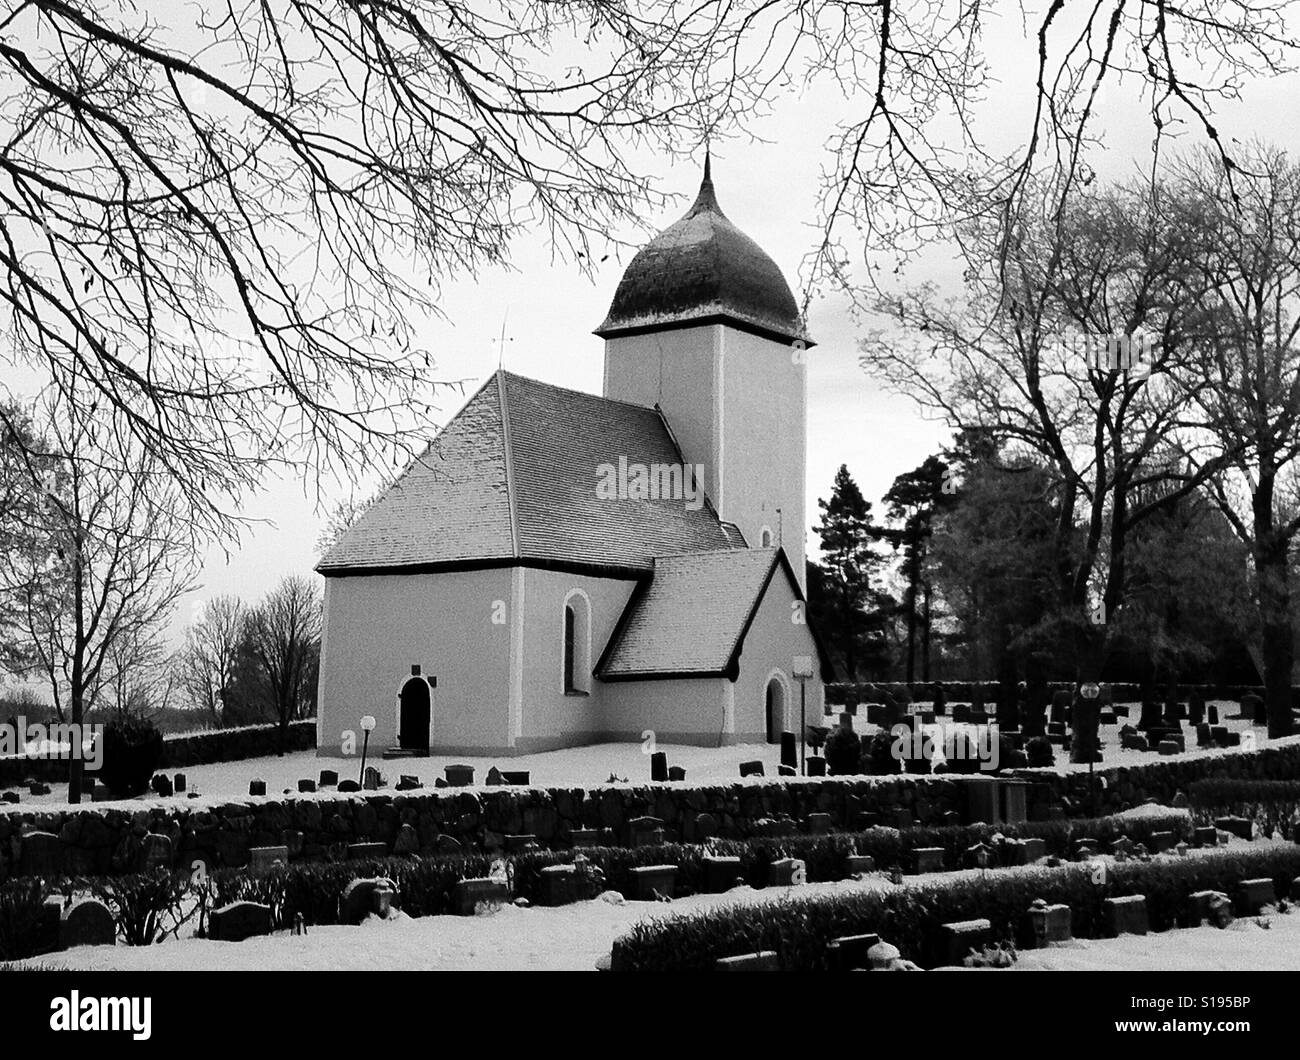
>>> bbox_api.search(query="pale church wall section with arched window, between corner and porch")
[514,568,636,754]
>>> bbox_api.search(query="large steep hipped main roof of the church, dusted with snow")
[317,372,731,575]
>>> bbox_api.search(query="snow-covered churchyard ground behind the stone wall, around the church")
[2,702,1300,806]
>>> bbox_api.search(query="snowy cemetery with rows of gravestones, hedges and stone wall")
[0,681,1300,970]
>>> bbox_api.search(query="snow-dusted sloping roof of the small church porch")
[595,549,829,680]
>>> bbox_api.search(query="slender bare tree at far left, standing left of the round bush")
[0,389,196,802]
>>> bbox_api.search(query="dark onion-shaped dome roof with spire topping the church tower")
[595,159,813,346]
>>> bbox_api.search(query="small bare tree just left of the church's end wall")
[244,576,322,753]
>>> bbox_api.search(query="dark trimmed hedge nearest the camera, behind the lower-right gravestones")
[612,847,1300,972]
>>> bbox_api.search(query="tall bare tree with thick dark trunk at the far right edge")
[1175,144,1300,736]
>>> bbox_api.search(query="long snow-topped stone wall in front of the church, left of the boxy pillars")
[0,776,971,878]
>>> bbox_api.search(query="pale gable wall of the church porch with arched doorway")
[736,571,823,744]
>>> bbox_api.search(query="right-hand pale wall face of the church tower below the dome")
[710,328,807,588]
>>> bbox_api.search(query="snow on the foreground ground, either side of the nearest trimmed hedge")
[0,839,1300,972]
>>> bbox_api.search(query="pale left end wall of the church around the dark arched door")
[317,570,512,757]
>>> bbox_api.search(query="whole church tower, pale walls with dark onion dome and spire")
[595,156,814,590]
